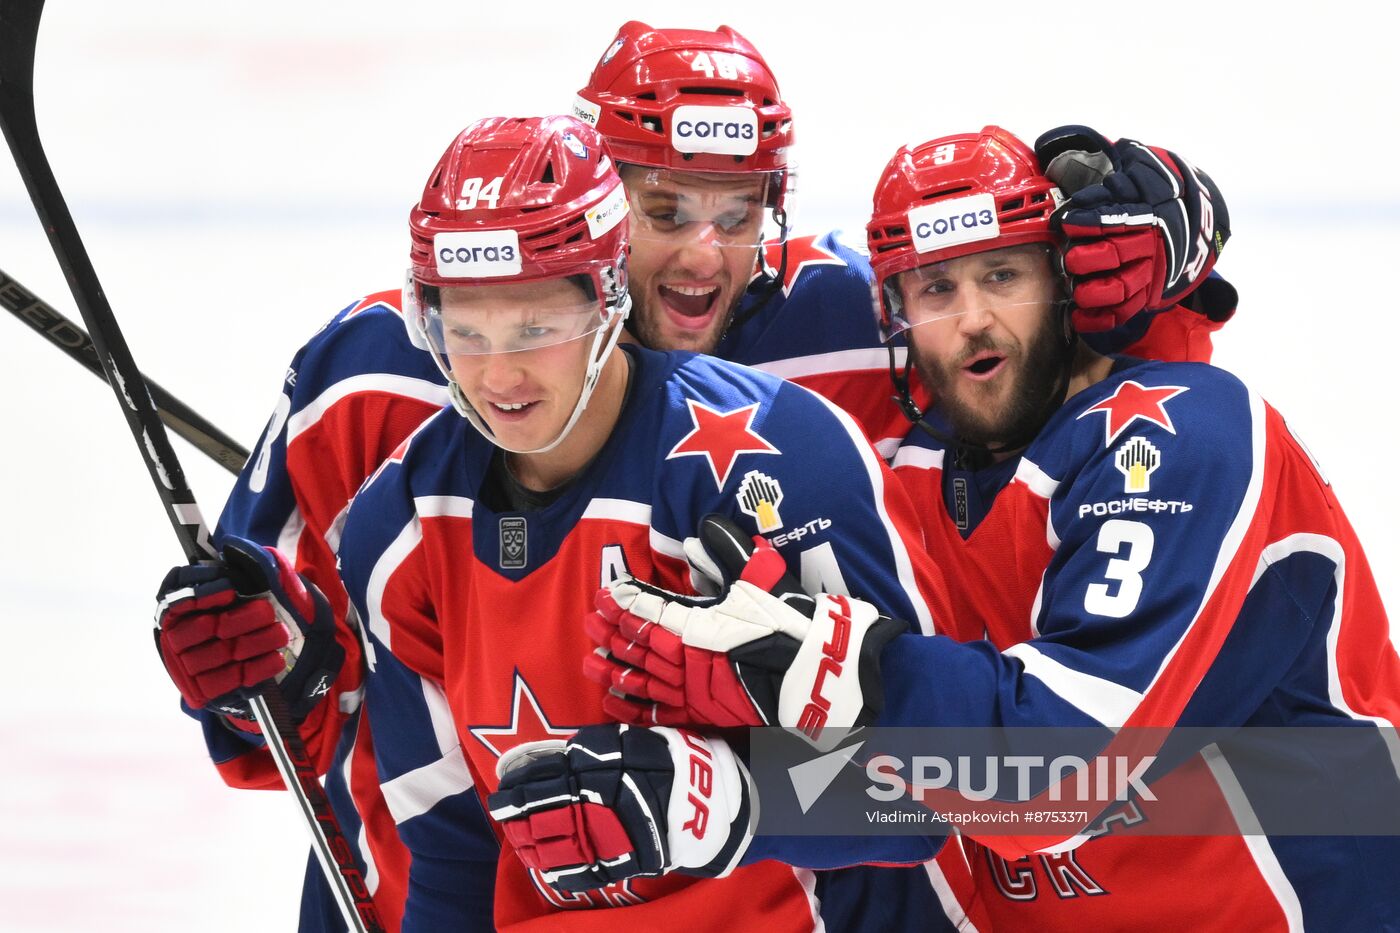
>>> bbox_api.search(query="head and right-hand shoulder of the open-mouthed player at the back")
[573,22,924,452]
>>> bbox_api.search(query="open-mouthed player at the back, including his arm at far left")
[153,24,1232,930]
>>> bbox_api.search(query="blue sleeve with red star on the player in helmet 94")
[654,357,944,632]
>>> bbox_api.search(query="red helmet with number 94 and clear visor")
[403,116,630,452]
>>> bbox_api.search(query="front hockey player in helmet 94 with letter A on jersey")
[329,118,963,930]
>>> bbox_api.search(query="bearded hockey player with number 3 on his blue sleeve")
[523,127,1400,930]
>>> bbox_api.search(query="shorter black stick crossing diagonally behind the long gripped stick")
[0,269,248,475]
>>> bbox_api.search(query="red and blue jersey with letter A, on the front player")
[340,347,974,930]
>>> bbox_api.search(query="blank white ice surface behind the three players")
[0,0,1400,933]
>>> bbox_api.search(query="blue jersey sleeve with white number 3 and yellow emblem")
[879,367,1271,728]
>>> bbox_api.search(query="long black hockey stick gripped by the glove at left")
[0,0,384,933]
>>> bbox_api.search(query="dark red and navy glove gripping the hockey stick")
[155,538,344,728]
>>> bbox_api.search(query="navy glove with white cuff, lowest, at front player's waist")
[487,724,753,892]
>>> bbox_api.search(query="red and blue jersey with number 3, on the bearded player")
[883,359,1400,930]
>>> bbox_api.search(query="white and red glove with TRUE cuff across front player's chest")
[584,516,907,747]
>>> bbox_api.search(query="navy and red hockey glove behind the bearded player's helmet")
[1036,126,1229,333]
